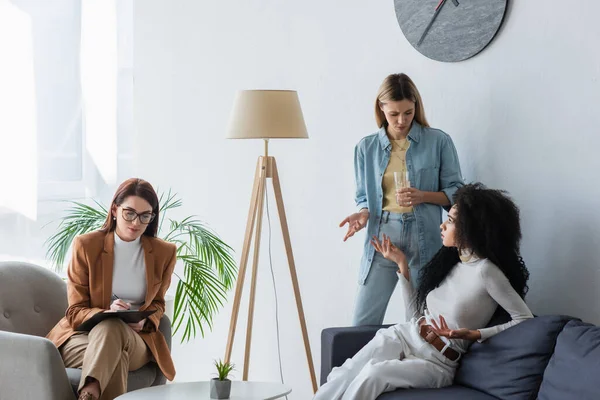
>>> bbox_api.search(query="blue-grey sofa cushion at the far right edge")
[538,321,600,400]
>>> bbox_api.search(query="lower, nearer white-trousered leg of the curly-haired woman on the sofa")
[342,356,454,400]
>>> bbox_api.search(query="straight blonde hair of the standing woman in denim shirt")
[375,74,429,128]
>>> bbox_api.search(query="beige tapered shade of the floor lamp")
[227,90,308,139]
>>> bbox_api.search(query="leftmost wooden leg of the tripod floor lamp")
[225,157,262,362]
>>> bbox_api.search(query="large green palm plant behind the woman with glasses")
[46,191,237,342]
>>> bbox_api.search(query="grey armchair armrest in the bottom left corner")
[0,331,75,400]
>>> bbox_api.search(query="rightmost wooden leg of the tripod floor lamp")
[270,157,318,393]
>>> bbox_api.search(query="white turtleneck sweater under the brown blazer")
[113,232,147,310]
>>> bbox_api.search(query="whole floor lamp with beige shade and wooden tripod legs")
[225,90,317,392]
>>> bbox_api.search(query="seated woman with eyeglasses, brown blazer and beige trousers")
[47,178,177,400]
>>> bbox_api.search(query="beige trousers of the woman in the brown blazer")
[59,318,151,400]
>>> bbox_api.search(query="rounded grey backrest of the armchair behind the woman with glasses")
[0,261,68,336]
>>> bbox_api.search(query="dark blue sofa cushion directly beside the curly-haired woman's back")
[454,315,573,400]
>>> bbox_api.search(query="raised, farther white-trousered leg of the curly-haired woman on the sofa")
[314,326,408,400]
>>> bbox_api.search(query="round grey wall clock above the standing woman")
[394,0,508,62]
